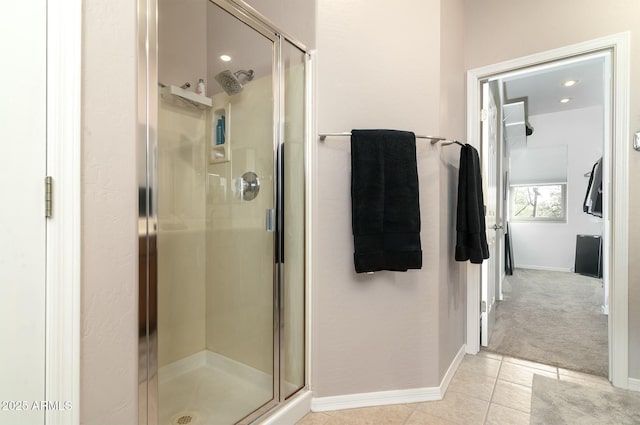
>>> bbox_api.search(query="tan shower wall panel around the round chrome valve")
[206,75,274,374]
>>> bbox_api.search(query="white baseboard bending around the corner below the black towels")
[311,345,466,412]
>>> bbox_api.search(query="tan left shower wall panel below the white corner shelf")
[158,98,206,367]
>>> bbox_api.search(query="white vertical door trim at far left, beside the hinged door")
[43,0,82,425]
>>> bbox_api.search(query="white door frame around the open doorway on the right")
[466,32,630,388]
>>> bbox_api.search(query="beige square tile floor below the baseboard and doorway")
[297,351,612,425]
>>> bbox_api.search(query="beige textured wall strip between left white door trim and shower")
[80,0,138,425]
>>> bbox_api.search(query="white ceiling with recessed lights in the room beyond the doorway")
[501,55,604,116]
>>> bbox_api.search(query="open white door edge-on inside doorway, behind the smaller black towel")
[480,83,500,347]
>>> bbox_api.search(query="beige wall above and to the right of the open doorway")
[465,0,640,378]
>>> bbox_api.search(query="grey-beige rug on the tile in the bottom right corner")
[530,375,640,425]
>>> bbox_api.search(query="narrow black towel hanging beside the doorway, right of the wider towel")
[455,145,489,264]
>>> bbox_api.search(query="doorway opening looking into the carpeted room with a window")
[482,52,610,376]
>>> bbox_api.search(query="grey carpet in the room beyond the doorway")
[488,269,609,376]
